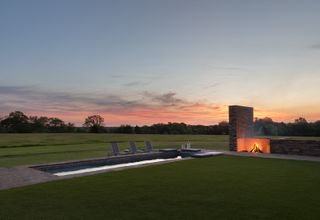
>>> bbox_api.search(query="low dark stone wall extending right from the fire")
[270,139,320,156]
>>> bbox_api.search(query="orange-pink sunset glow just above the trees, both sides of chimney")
[18,103,320,126]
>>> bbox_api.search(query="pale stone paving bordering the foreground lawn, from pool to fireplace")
[0,151,320,190]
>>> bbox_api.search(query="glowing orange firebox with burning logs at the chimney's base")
[237,138,270,154]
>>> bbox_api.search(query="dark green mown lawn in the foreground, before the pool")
[0,156,320,220]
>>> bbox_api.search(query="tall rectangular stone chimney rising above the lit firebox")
[229,105,253,151]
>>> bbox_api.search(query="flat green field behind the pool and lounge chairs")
[0,133,228,167]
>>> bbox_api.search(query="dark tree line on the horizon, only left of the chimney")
[0,111,228,134]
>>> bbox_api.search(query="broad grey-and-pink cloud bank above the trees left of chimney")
[0,86,226,125]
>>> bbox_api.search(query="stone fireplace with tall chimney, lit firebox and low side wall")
[229,105,320,156]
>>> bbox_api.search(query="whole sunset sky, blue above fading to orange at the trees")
[0,0,320,126]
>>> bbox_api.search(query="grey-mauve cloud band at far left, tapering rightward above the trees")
[0,86,143,111]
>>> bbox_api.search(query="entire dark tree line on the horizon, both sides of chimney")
[0,111,320,136]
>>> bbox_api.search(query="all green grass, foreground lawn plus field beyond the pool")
[0,134,320,220]
